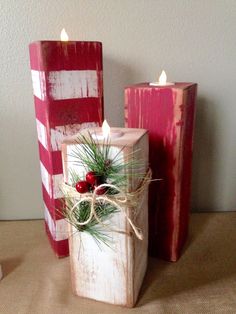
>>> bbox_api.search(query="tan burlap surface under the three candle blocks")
[0,212,236,314]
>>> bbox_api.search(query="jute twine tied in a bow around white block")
[62,169,152,240]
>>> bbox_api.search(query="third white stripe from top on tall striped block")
[40,162,63,199]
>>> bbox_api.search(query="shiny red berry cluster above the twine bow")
[75,171,107,195]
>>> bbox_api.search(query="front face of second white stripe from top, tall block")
[50,122,99,151]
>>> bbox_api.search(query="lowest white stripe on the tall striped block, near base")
[44,204,68,241]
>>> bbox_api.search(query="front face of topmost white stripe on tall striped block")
[48,70,98,100]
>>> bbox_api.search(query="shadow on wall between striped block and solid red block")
[103,55,141,127]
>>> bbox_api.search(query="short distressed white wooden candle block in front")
[62,129,148,307]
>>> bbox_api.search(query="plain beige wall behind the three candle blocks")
[0,0,236,219]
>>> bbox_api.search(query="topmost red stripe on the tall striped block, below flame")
[29,41,102,71]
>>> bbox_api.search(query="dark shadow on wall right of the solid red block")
[192,96,218,211]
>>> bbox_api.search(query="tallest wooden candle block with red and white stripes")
[29,41,103,257]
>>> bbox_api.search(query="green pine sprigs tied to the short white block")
[64,132,146,246]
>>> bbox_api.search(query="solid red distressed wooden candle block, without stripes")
[125,83,197,261]
